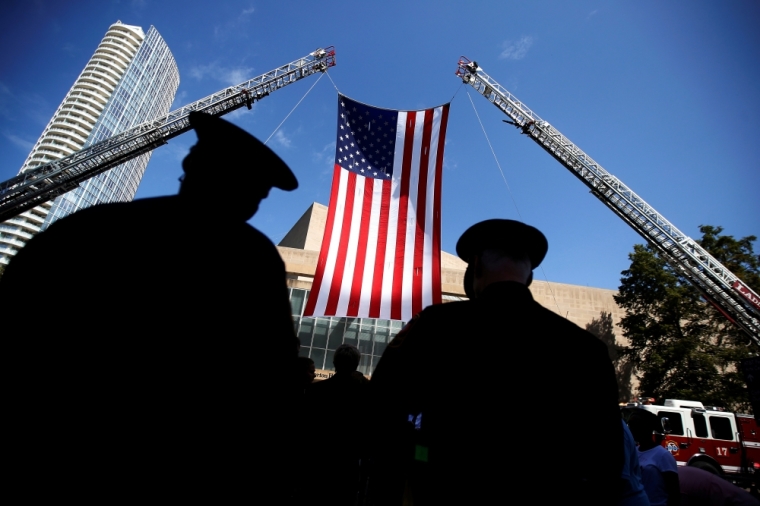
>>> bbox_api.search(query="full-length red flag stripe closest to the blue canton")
[391,111,417,320]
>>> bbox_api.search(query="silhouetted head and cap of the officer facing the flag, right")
[457,219,549,298]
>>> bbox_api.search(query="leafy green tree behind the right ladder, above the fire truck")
[615,225,760,412]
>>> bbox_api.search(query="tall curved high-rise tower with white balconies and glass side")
[0,21,179,264]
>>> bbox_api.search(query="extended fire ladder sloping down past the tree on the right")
[456,57,760,344]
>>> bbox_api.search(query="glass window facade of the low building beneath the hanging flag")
[289,288,404,375]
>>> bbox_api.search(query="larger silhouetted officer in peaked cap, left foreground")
[0,112,298,502]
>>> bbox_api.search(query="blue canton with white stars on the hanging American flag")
[335,95,398,179]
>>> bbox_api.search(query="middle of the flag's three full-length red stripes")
[412,109,433,315]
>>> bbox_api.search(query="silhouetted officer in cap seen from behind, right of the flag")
[370,219,623,504]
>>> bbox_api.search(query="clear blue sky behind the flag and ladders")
[0,0,760,289]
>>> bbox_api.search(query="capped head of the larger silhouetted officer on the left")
[180,111,298,221]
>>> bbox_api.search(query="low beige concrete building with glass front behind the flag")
[277,202,623,378]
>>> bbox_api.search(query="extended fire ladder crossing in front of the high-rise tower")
[0,46,336,222]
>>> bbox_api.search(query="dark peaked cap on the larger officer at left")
[188,111,298,191]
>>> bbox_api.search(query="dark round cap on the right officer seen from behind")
[457,219,549,269]
